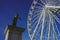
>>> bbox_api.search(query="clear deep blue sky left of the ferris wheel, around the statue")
[0,0,32,40]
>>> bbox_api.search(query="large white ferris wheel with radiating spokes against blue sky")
[27,0,60,40]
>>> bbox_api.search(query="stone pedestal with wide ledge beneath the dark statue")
[4,25,24,40]
